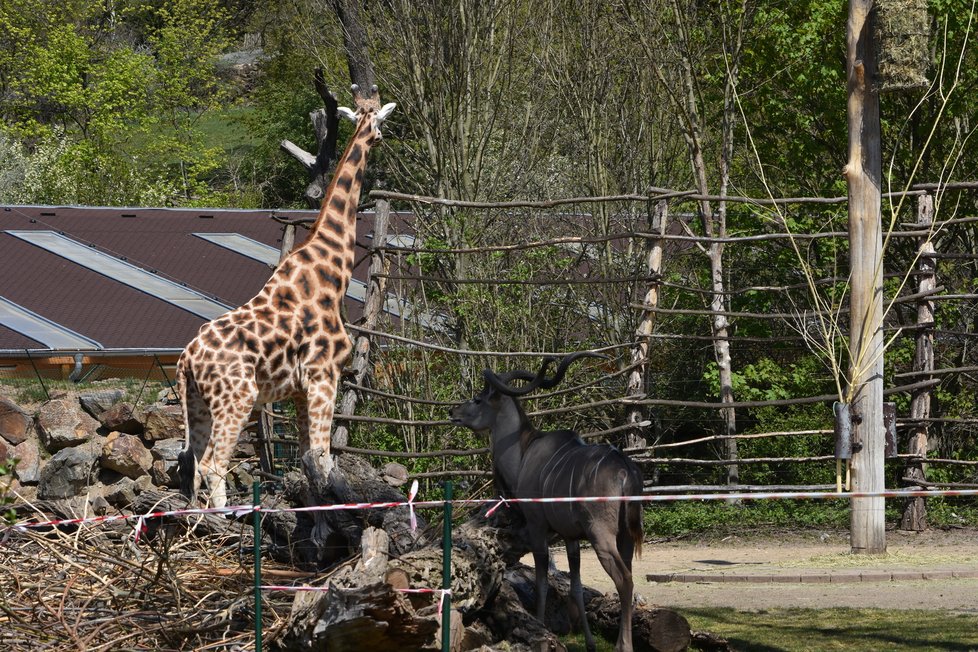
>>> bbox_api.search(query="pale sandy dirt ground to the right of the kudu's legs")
[524,528,978,615]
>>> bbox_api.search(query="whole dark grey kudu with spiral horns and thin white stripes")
[451,352,642,652]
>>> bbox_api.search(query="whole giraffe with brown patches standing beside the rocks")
[176,98,395,507]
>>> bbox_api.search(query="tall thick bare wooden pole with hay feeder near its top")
[845,0,886,554]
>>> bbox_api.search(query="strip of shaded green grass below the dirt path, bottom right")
[564,608,978,652]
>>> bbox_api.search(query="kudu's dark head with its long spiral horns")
[450,351,607,432]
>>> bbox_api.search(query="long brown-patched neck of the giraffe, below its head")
[308,114,373,243]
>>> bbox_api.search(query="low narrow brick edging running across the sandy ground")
[645,570,978,584]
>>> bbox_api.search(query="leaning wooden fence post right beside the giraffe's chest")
[333,199,390,446]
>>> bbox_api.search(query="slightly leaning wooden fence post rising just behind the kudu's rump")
[625,201,669,448]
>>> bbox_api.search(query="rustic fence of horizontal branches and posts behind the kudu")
[250,183,978,524]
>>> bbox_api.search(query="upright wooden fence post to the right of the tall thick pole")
[900,195,937,532]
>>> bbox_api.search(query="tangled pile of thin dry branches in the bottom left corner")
[0,510,288,652]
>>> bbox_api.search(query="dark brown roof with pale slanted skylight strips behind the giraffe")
[0,206,404,355]
